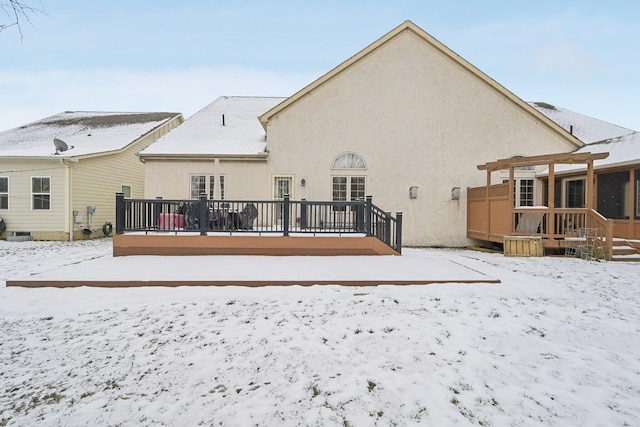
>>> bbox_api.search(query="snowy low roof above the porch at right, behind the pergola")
[540,132,640,175]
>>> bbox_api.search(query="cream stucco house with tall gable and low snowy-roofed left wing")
[141,21,584,246]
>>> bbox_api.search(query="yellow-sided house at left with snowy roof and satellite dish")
[0,112,183,240]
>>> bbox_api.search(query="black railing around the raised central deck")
[116,193,402,253]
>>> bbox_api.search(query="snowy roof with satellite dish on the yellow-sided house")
[0,111,180,157]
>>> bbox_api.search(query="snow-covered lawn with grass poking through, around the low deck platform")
[0,239,640,426]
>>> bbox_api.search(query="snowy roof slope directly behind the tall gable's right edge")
[529,102,633,144]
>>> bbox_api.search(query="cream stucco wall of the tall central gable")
[268,32,572,246]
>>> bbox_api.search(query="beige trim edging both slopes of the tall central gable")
[260,21,584,153]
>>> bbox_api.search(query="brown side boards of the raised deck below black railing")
[113,233,400,257]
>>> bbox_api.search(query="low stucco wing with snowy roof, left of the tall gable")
[140,96,285,199]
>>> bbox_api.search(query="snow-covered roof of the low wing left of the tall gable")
[140,96,286,157]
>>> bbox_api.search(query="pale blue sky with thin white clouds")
[0,0,640,131]
